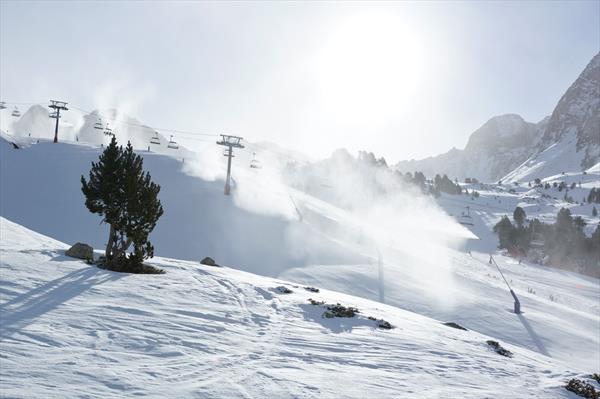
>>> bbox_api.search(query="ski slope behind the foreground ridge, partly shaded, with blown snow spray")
[0,140,600,369]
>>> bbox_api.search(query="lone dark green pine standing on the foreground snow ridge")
[81,136,163,271]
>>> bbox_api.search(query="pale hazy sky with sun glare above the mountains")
[0,0,600,163]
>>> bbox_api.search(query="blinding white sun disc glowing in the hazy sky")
[315,14,424,123]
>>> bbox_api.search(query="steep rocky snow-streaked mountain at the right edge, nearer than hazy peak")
[504,53,600,181]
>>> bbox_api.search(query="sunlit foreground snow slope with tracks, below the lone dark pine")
[0,218,582,398]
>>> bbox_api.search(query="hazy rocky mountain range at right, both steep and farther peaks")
[396,54,600,182]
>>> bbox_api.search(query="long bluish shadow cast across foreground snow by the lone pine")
[0,266,123,338]
